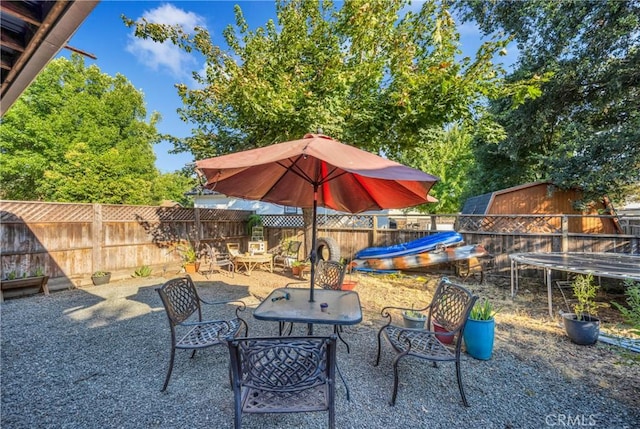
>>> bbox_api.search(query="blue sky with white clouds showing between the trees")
[59,0,515,172]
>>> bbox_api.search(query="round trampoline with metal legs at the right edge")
[509,252,640,317]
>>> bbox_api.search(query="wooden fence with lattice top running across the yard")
[0,201,640,289]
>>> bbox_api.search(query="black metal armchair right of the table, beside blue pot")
[375,277,478,407]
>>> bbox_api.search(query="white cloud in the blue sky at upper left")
[126,3,205,78]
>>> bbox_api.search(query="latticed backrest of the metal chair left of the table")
[156,275,202,326]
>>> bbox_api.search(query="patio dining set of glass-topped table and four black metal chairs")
[156,270,477,428]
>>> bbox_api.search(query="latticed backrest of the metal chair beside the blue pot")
[428,277,478,332]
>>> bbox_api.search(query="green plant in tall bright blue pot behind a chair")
[462,298,498,360]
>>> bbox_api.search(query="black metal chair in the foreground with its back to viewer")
[228,335,336,429]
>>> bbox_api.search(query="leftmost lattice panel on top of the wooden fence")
[0,201,93,223]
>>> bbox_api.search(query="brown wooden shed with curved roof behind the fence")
[462,182,620,234]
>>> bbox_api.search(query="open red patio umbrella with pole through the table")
[196,134,438,302]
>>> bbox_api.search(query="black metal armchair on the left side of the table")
[156,275,249,392]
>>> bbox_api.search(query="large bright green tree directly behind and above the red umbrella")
[123,1,535,211]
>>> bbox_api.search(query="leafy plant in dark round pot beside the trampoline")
[560,274,600,346]
